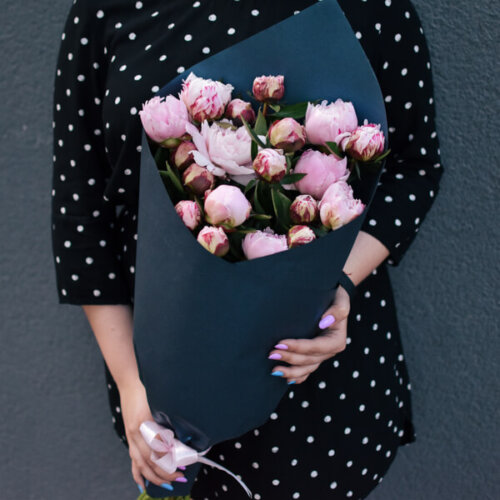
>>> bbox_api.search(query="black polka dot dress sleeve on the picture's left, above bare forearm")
[51,0,130,305]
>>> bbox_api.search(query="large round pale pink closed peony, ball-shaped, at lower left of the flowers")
[204,184,252,229]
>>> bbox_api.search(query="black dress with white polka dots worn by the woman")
[52,0,442,500]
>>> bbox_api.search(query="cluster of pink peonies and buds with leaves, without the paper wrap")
[140,73,389,262]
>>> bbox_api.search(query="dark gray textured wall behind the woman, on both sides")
[0,0,500,500]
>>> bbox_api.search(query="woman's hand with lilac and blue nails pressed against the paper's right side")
[269,286,350,384]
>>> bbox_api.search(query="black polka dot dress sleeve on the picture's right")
[362,0,443,266]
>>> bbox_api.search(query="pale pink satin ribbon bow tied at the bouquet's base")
[139,420,252,498]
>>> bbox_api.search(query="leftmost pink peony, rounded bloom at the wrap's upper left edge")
[139,95,189,146]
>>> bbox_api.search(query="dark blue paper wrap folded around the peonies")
[134,0,387,496]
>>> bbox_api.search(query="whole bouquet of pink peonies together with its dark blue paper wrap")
[134,0,387,496]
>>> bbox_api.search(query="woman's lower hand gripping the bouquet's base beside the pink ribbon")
[120,381,186,490]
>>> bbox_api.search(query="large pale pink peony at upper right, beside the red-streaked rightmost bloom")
[305,99,358,145]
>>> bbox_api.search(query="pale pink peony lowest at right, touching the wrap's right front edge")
[319,181,365,229]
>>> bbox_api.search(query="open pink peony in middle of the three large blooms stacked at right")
[293,149,349,200]
